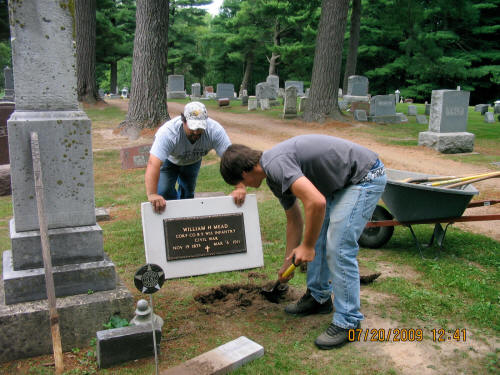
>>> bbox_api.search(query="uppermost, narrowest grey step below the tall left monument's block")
[10,219,104,271]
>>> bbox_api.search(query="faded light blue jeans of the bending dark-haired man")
[307,166,387,329]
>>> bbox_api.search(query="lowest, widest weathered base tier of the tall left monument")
[0,281,134,362]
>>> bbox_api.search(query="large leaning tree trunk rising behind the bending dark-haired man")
[304,0,349,122]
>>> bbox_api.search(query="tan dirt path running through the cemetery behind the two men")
[98,99,500,241]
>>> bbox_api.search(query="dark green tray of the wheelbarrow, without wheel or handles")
[382,169,479,222]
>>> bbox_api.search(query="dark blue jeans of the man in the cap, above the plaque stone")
[158,159,201,200]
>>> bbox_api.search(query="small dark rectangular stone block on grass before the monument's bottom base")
[96,324,161,368]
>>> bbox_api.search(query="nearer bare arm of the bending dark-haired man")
[287,176,326,264]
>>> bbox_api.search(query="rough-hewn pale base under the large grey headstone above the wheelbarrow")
[418,131,474,154]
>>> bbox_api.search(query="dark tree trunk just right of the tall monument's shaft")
[75,0,100,103]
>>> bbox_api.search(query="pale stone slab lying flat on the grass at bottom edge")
[160,336,264,375]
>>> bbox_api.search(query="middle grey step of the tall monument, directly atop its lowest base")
[3,250,116,305]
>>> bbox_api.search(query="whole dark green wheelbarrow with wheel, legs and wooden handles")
[358,169,500,258]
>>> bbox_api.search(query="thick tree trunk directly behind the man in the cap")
[120,0,170,134]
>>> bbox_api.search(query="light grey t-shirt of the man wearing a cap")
[149,116,231,165]
